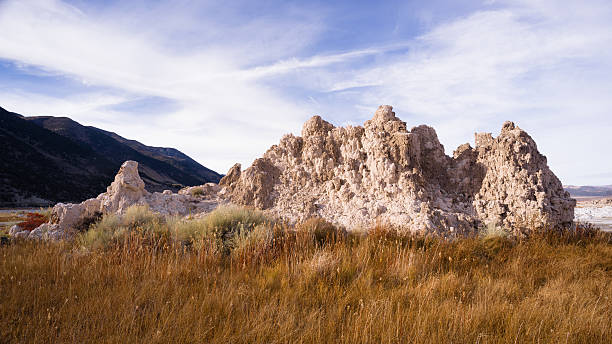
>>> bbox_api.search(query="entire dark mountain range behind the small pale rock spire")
[0,108,221,206]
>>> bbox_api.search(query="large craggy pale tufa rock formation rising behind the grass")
[220,105,575,234]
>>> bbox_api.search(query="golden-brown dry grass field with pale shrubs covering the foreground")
[0,209,612,343]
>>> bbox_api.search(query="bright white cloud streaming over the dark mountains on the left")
[0,0,326,172]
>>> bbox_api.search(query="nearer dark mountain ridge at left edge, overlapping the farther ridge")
[0,108,114,206]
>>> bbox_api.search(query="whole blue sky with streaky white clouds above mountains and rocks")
[0,0,612,185]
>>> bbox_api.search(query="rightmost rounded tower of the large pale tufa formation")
[474,122,576,234]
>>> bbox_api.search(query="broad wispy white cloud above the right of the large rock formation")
[252,1,612,184]
